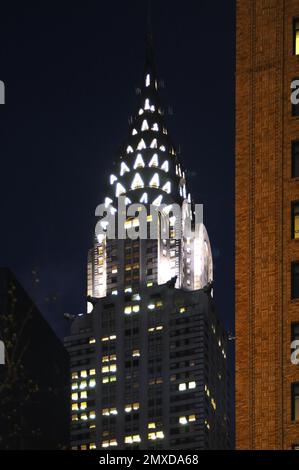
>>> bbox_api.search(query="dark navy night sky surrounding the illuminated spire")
[0,0,235,337]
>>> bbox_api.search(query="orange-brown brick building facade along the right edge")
[236,0,299,449]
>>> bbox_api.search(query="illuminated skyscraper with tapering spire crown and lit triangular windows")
[65,37,231,449]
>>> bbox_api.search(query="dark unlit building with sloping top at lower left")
[0,268,70,450]
